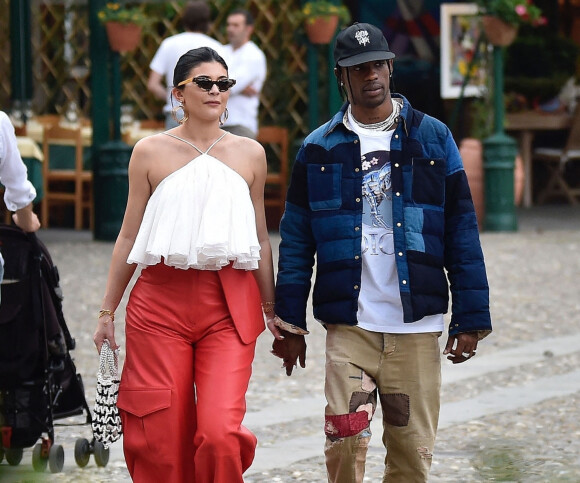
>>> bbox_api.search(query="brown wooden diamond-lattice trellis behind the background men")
[0,0,326,144]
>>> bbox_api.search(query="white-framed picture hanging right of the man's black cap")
[441,3,486,99]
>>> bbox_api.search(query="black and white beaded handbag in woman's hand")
[92,340,123,448]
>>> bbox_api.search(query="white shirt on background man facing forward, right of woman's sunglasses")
[224,41,267,133]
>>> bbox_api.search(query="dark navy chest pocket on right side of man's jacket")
[412,158,446,206]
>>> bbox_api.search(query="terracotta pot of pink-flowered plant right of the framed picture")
[475,0,547,46]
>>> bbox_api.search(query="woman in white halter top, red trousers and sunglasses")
[94,47,279,483]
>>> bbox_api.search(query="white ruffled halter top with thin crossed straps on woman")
[127,132,260,270]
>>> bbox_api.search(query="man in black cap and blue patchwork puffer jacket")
[273,23,491,483]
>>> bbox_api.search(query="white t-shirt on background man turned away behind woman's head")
[149,32,224,112]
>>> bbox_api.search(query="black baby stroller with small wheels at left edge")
[0,225,109,473]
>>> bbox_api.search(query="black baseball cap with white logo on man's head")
[334,23,395,67]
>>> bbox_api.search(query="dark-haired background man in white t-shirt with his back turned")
[147,1,224,129]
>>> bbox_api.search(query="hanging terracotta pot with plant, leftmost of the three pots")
[97,2,147,52]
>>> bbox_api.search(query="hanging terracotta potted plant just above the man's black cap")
[301,0,350,44]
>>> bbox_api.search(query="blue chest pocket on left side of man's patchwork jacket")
[307,164,342,211]
